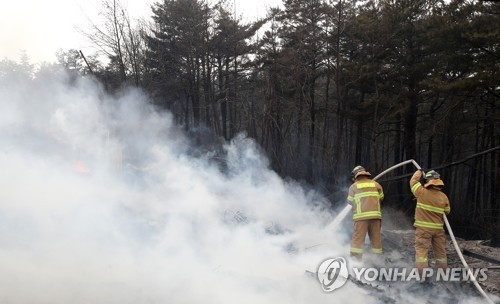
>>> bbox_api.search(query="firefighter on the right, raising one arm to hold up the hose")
[410,170,450,271]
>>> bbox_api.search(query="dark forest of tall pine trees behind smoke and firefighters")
[0,0,500,244]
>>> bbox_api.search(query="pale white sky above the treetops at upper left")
[0,0,281,63]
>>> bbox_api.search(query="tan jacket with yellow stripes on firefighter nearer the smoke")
[347,176,384,221]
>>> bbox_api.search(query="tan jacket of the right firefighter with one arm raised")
[410,170,450,230]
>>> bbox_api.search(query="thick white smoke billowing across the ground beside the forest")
[0,69,368,303]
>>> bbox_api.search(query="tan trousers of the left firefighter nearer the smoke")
[351,219,382,258]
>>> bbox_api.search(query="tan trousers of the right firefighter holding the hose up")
[415,228,447,270]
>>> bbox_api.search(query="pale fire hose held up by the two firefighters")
[327,159,494,304]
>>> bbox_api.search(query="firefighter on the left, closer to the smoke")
[347,166,384,259]
